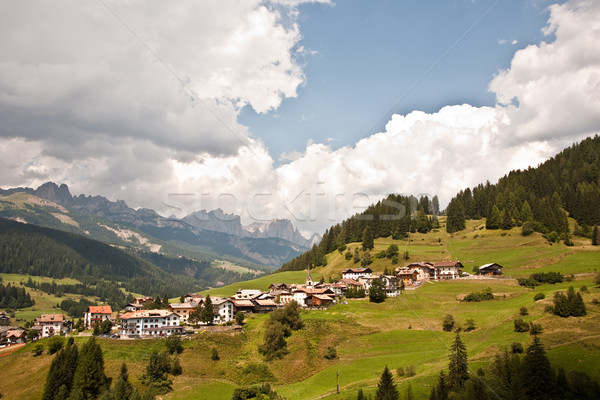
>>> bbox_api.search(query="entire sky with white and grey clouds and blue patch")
[0,0,600,235]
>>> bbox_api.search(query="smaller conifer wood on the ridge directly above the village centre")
[279,194,440,271]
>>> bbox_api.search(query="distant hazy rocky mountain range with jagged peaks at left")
[0,182,320,269]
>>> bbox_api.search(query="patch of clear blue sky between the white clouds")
[240,0,564,159]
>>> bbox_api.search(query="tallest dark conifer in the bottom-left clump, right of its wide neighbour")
[73,337,107,398]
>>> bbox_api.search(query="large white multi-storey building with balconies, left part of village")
[120,310,183,336]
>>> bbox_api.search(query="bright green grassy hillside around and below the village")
[0,221,600,400]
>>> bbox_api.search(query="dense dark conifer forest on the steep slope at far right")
[446,135,600,238]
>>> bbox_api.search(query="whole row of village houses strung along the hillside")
[0,261,502,345]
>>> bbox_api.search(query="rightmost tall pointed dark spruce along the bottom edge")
[522,336,554,399]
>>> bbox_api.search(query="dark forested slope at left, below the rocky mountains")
[0,218,205,299]
